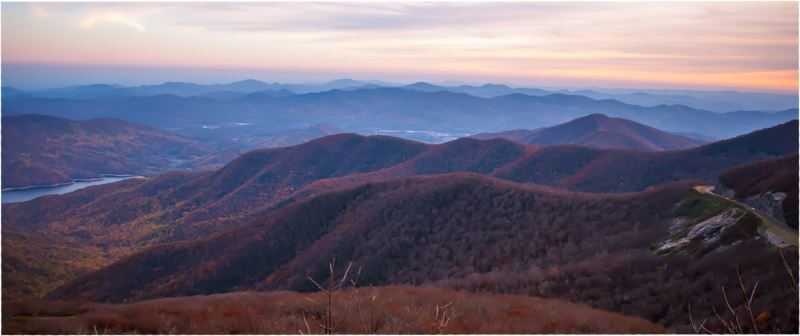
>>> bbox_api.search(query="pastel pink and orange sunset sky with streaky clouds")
[2,2,798,93]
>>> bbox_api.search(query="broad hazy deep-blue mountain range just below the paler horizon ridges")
[3,83,798,139]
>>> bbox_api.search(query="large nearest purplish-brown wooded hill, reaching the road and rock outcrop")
[50,173,796,327]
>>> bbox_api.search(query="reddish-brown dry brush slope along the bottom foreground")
[3,287,664,334]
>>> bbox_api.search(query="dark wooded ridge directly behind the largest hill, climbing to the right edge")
[315,121,798,192]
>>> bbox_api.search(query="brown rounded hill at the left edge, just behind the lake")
[2,115,209,188]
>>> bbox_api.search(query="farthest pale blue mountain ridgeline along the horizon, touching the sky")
[3,79,798,112]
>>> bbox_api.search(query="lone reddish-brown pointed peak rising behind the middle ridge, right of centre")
[473,114,705,151]
